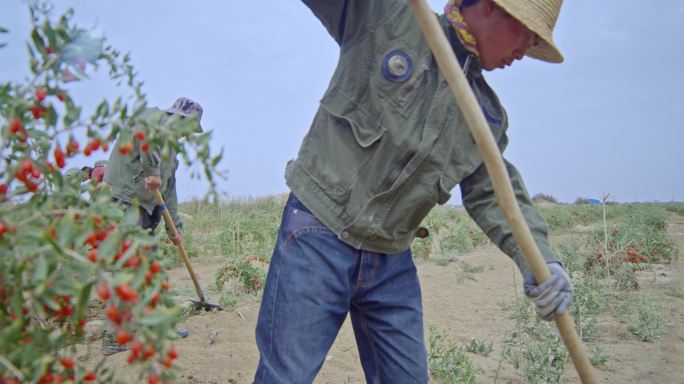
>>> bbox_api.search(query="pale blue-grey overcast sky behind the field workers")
[0,0,684,204]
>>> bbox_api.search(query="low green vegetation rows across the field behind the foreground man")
[171,194,684,302]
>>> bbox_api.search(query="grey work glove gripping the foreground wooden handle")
[523,262,574,321]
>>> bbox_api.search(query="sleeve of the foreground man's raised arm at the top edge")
[302,0,405,45]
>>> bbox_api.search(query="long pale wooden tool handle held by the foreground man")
[409,0,596,384]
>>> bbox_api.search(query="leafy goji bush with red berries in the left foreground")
[0,1,221,384]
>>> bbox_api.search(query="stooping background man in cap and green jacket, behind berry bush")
[104,97,202,245]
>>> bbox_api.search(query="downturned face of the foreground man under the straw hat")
[476,0,537,71]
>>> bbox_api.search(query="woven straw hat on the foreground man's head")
[456,0,563,63]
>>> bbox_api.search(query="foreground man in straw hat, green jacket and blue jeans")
[254,0,572,383]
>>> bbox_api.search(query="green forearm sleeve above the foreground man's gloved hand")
[460,161,560,274]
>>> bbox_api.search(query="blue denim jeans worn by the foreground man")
[254,194,428,384]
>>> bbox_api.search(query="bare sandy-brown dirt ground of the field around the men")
[94,214,684,384]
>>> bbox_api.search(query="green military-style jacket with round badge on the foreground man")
[285,0,558,272]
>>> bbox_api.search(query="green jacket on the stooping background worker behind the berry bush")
[104,108,182,232]
